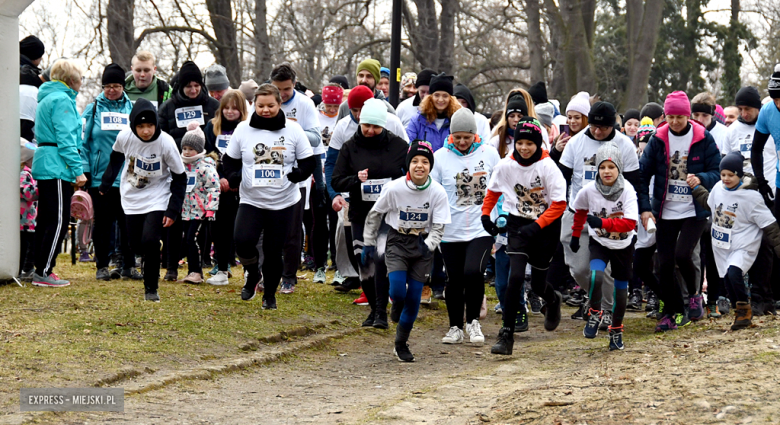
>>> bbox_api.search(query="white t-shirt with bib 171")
[114,127,184,214]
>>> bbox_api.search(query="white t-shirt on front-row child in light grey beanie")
[567,181,639,249]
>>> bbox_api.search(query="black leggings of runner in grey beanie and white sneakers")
[441,236,493,329]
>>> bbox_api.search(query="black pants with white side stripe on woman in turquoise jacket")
[35,179,73,277]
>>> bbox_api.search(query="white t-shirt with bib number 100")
[226,120,314,210]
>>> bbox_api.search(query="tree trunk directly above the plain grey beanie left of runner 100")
[206,0,241,88]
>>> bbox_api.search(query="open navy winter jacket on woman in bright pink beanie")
[635,120,721,220]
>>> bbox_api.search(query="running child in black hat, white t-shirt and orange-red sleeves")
[482,117,566,355]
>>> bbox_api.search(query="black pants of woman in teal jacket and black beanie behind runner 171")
[89,188,135,269]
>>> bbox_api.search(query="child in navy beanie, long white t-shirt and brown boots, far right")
[688,152,780,331]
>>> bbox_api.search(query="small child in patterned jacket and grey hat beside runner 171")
[181,122,220,284]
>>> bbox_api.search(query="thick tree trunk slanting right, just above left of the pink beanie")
[620,0,664,111]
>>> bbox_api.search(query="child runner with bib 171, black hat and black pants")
[99,98,187,302]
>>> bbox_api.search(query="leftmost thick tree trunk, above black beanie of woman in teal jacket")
[106,0,135,70]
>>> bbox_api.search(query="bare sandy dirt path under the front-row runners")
[18,307,780,425]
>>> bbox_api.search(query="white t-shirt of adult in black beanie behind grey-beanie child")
[561,130,640,202]
